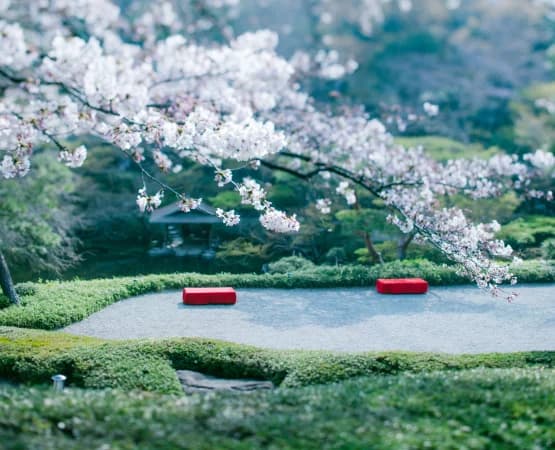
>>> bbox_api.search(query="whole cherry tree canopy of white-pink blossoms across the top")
[0,0,552,304]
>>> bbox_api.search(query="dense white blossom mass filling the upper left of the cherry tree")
[0,0,307,236]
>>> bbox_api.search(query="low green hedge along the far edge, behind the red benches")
[0,260,555,330]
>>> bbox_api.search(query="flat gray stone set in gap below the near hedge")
[177,370,275,393]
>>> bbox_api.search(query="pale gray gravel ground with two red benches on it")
[64,284,555,353]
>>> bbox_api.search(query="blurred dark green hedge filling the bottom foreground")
[0,369,555,450]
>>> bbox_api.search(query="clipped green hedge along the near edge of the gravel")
[0,327,555,393]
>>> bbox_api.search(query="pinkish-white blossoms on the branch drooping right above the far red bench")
[273,101,555,297]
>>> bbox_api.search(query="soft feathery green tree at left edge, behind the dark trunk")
[0,153,80,303]
